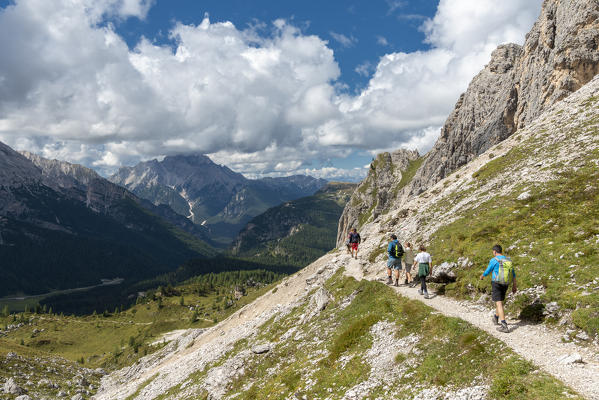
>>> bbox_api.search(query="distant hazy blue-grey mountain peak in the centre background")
[109,154,326,246]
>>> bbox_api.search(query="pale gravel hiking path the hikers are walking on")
[340,255,599,400]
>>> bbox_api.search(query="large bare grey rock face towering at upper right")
[410,0,599,195]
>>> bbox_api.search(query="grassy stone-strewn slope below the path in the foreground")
[155,273,579,399]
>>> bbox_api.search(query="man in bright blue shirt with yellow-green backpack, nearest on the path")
[480,244,518,333]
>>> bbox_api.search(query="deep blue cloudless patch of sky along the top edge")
[112,0,438,91]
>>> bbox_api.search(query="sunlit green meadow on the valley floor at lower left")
[0,271,282,395]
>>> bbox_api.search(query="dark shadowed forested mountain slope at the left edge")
[0,143,215,296]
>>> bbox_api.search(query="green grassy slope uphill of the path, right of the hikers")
[422,98,599,336]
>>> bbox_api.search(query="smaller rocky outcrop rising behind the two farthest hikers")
[337,149,420,245]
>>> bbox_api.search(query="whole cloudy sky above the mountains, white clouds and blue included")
[0,0,542,181]
